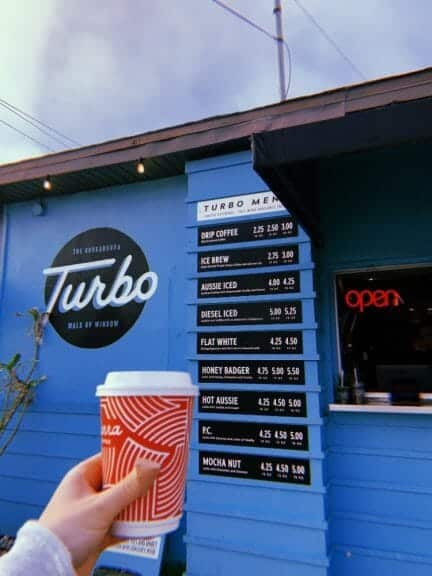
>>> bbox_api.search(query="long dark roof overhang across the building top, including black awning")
[0,68,432,212]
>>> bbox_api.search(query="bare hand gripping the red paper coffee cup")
[39,454,159,576]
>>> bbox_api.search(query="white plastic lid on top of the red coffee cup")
[96,371,199,396]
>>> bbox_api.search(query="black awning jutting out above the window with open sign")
[252,93,432,242]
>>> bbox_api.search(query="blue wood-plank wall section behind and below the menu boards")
[186,152,327,576]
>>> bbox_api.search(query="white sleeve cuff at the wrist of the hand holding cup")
[0,520,75,576]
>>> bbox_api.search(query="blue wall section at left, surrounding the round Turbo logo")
[0,177,187,560]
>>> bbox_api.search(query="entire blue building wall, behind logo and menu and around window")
[0,140,432,576]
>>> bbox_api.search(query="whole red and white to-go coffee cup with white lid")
[96,371,198,538]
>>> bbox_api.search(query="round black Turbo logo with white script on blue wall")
[43,228,158,348]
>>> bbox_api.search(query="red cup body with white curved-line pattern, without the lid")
[101,396,192,522]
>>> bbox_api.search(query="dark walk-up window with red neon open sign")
[336,266,432,406]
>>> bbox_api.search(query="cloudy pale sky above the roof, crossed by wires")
[0,0,432,164]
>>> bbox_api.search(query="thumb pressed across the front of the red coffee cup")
[101,460,160,518]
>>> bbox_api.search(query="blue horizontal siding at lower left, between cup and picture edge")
[0,408,100,534]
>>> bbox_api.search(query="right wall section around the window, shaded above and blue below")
[317,144,432,576]
